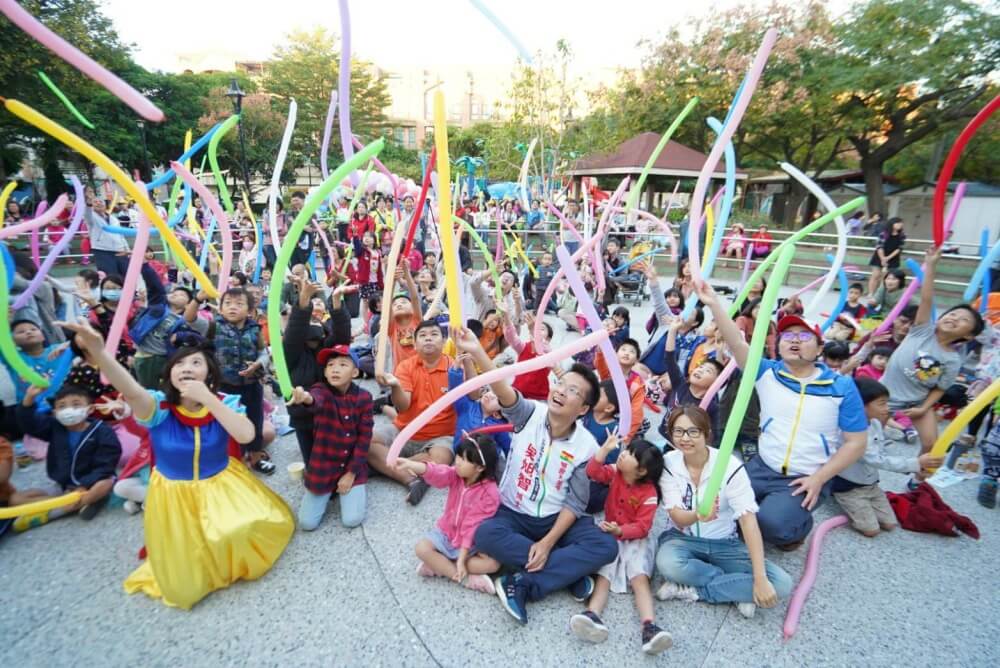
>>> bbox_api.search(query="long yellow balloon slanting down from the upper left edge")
[4,99,219,299]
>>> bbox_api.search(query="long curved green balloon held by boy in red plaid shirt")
[268,136,385,399]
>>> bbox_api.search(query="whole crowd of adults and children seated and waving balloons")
[0,185,1000,654]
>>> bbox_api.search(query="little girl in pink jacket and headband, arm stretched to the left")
[396,434,500,594]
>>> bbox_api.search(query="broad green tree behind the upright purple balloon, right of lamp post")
[263,28,391,175]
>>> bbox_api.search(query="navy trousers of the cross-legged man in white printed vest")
[476,506,618,601]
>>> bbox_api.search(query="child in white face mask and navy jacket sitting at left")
[14,385,122,531]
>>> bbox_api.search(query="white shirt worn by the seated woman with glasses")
[660,448,758,540]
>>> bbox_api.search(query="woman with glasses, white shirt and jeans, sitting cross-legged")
[656,406,792,617]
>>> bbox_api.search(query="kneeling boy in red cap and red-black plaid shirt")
[289,345,375,531]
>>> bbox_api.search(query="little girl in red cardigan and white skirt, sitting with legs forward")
[569,434,673,654]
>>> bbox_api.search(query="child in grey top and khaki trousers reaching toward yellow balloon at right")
[832,378,944,538]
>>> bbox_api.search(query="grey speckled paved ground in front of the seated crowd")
[0,286,1000,667]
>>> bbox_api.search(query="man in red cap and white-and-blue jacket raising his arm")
[695,282,868,550]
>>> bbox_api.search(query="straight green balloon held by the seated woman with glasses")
[698,243,795,515]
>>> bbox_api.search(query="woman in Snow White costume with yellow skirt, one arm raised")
[62,321,295,609]
